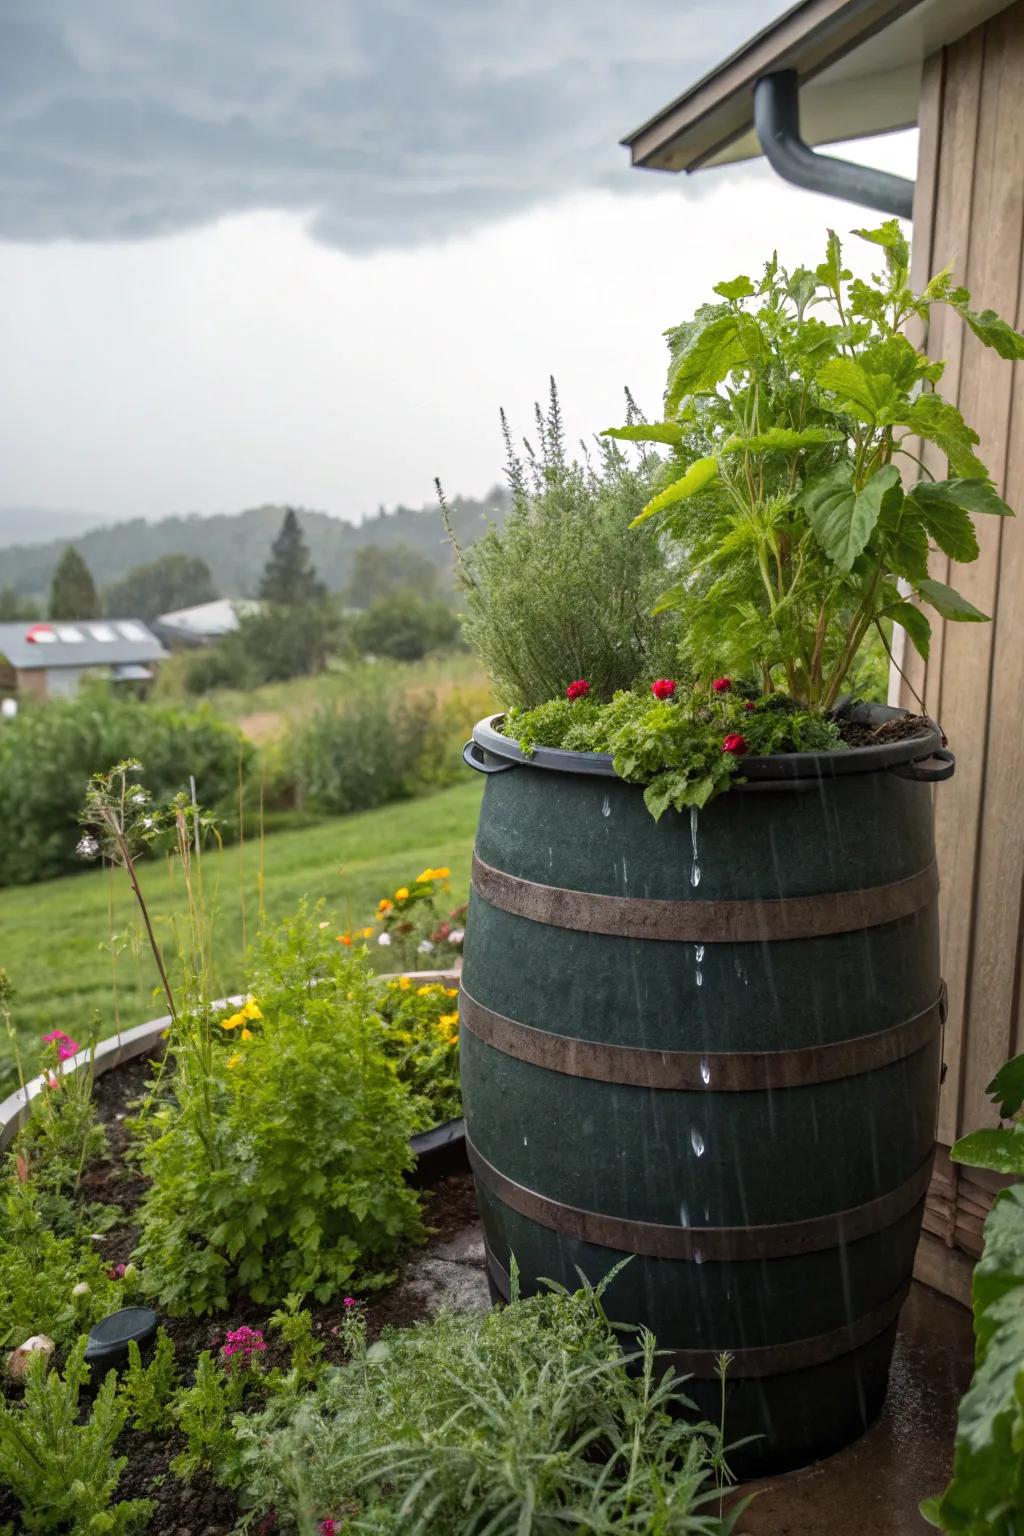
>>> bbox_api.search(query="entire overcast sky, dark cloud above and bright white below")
[0,0,915,533]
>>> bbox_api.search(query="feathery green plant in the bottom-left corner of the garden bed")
[0,1338,154,1536]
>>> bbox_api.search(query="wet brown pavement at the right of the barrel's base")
[737,1284,973,1536]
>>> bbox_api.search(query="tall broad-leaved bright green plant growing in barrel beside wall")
[604,220,1024,710]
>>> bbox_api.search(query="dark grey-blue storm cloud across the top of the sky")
[0,0,781,250]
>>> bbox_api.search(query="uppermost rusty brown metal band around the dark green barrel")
[473,852,938,945]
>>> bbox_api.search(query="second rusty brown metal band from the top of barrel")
[459,988,944,1094]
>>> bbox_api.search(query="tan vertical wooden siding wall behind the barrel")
[900,0,1024,1284]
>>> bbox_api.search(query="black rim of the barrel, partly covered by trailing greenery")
[473,705,944,780]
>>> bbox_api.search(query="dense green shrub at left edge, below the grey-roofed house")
[0,687,253,886]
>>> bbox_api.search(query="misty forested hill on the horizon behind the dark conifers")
[0,487,508,599]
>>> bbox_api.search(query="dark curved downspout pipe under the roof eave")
[754,69,913,218]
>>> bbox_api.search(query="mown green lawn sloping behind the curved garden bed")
[0,776,481,1094]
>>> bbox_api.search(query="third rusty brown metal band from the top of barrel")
[465,1135,932,1263]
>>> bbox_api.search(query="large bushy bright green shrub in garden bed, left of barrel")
[131,914,421,1315]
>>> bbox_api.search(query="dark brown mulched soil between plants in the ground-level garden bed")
[0,1057,476,1536]
